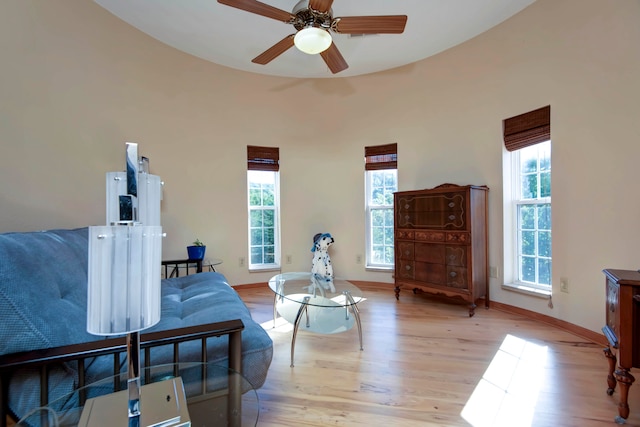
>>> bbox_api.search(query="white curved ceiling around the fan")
[94,0,535,78]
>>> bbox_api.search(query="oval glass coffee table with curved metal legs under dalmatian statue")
[269,273,364,367]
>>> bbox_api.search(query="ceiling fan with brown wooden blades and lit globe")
[218,0,407,74]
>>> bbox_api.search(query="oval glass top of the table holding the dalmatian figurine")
[269,272,363,307]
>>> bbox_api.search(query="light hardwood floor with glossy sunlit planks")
[236,282,640,427]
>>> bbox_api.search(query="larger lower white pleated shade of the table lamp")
[87,225,162,335]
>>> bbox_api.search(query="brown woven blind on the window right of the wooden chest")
[503,105,551,151]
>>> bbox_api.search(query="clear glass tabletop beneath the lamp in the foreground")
[16,362,260,427]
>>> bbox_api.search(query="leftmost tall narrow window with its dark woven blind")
[247,145,280,270]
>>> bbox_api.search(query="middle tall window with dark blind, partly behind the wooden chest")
[364,144,398,269]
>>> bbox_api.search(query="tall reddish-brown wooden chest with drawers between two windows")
[394,184,489,316]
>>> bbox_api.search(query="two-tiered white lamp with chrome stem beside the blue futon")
[87,142,163,426]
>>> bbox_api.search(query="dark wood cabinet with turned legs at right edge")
[602,269,640,424]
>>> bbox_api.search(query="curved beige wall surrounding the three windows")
[0,0,640,331]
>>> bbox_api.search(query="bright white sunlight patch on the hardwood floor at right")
[461,335,547,427]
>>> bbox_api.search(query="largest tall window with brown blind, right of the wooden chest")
[504,107,552,291]
